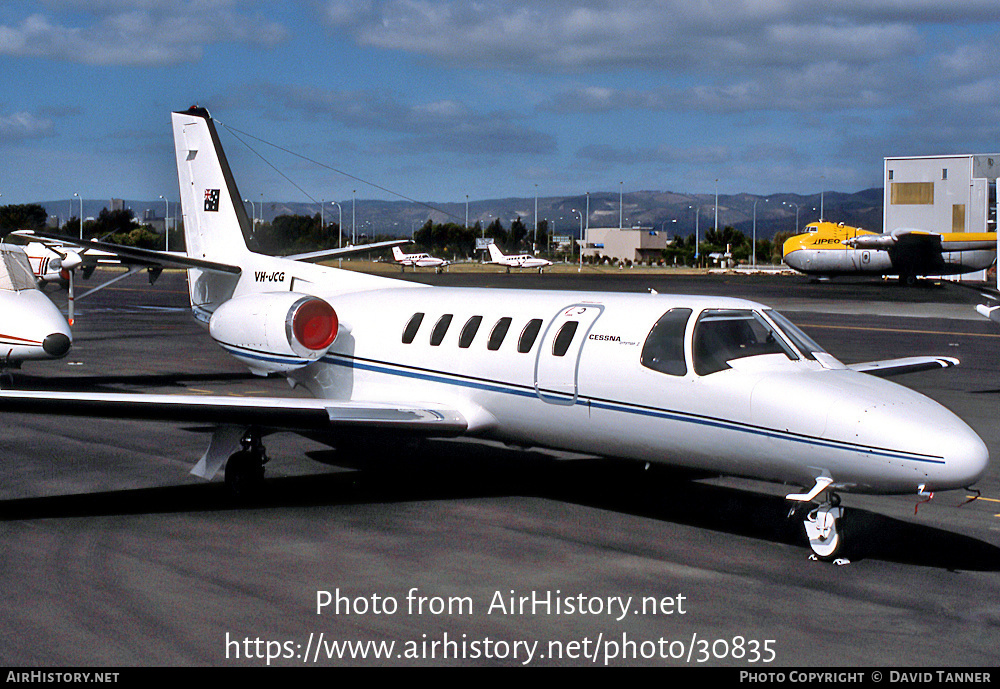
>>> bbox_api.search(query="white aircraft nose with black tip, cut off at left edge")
[0,244,73,369]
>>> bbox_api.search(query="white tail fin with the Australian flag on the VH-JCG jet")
[171,107,250,317]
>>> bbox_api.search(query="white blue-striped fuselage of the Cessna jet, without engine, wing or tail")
[201,256,987,493]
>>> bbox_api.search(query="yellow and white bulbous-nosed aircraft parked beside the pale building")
[782,221,997,284]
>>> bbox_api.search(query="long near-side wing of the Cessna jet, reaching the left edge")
[0,390,468,437]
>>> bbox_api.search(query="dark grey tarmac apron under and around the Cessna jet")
[0,271,1000,671]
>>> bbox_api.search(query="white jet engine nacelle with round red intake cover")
[208,292,340,374]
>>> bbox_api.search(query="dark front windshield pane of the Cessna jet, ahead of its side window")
[692,309,799,376]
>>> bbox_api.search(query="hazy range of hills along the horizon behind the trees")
[39,188,882,239]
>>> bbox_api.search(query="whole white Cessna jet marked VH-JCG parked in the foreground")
[0,107,988,559]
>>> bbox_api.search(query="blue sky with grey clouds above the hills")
[0,0,1000,208]
